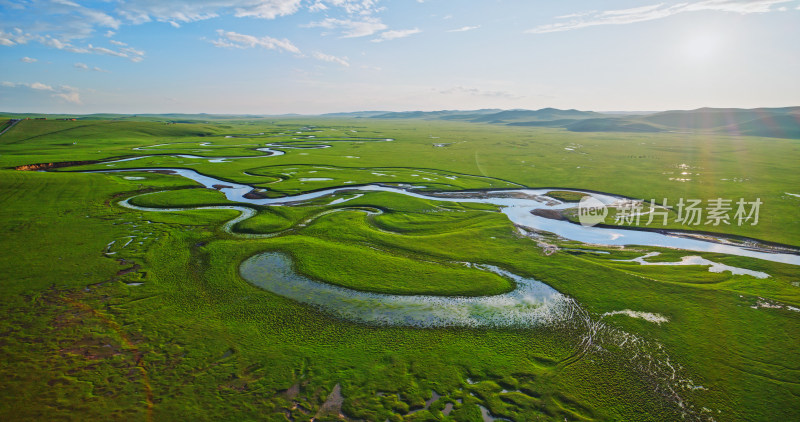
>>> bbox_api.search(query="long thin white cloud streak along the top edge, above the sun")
[525,0,794,34]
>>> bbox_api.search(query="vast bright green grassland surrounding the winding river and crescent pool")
[0,118,800,421]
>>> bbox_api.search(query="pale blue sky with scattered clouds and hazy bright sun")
[0,0,800,114]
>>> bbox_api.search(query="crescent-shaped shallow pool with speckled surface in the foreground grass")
[239,252,577,327]
